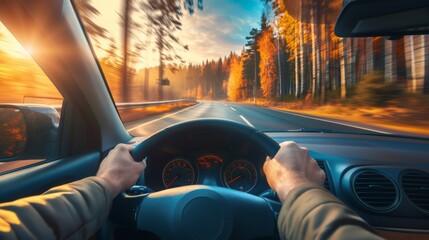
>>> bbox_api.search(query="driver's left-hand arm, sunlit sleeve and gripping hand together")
[0,144,145,239]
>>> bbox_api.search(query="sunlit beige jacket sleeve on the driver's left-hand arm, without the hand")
[0,177,113,239]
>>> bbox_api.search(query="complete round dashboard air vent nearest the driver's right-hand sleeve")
[353,170,398,211]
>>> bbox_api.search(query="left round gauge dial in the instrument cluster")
[162,159,195,188]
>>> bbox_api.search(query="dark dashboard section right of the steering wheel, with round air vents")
[268,133,429,233]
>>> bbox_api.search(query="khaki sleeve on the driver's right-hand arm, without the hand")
[277,185,382,240]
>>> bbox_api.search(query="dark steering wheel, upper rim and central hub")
[110,119,280,239]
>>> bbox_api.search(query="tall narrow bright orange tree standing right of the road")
[258,27,278,98]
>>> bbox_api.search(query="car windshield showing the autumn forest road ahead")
[74,0,429,137]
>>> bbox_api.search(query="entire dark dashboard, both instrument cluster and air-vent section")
[144,132,429,233]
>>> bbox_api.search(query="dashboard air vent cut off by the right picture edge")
[402,171,429,211]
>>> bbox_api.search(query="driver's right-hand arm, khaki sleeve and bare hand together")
[264,142,381,239]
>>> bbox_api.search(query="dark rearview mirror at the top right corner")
[335,0,429,38]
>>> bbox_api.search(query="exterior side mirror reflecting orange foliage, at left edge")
[0,104,60,161]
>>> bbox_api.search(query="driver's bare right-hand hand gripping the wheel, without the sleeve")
[264,142,326,202]
